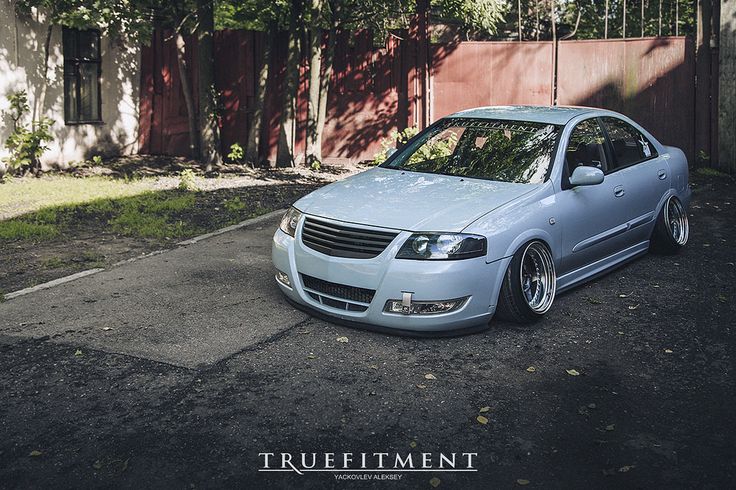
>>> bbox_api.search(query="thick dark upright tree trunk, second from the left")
[197,0,220,172]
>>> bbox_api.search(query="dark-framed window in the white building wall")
[62,28,102,124]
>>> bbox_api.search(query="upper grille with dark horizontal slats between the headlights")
[302,218,397,259]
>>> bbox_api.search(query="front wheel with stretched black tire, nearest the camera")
[496,240,557,323]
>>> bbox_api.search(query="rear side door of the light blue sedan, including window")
[601,117,670,246]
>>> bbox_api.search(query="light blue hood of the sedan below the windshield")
[295,168,537,232]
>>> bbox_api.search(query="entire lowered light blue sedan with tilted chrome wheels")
[272,106,690,332]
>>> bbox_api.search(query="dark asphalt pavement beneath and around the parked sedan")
[0,178,736,488]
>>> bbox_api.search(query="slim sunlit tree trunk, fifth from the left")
[306,0,322,168]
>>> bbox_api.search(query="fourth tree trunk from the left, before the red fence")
[276,0,301,167]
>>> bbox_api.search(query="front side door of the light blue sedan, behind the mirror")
[556,118,628,276]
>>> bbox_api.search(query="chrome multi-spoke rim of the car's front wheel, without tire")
[519,242,557,315]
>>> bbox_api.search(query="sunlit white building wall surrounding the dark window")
[0,0,140,173]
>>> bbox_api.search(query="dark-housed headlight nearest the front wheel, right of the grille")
[396,233,486,260]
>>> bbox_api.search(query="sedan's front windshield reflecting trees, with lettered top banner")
[381,118,559,184]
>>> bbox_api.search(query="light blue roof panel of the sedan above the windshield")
[448,105,609,125]
